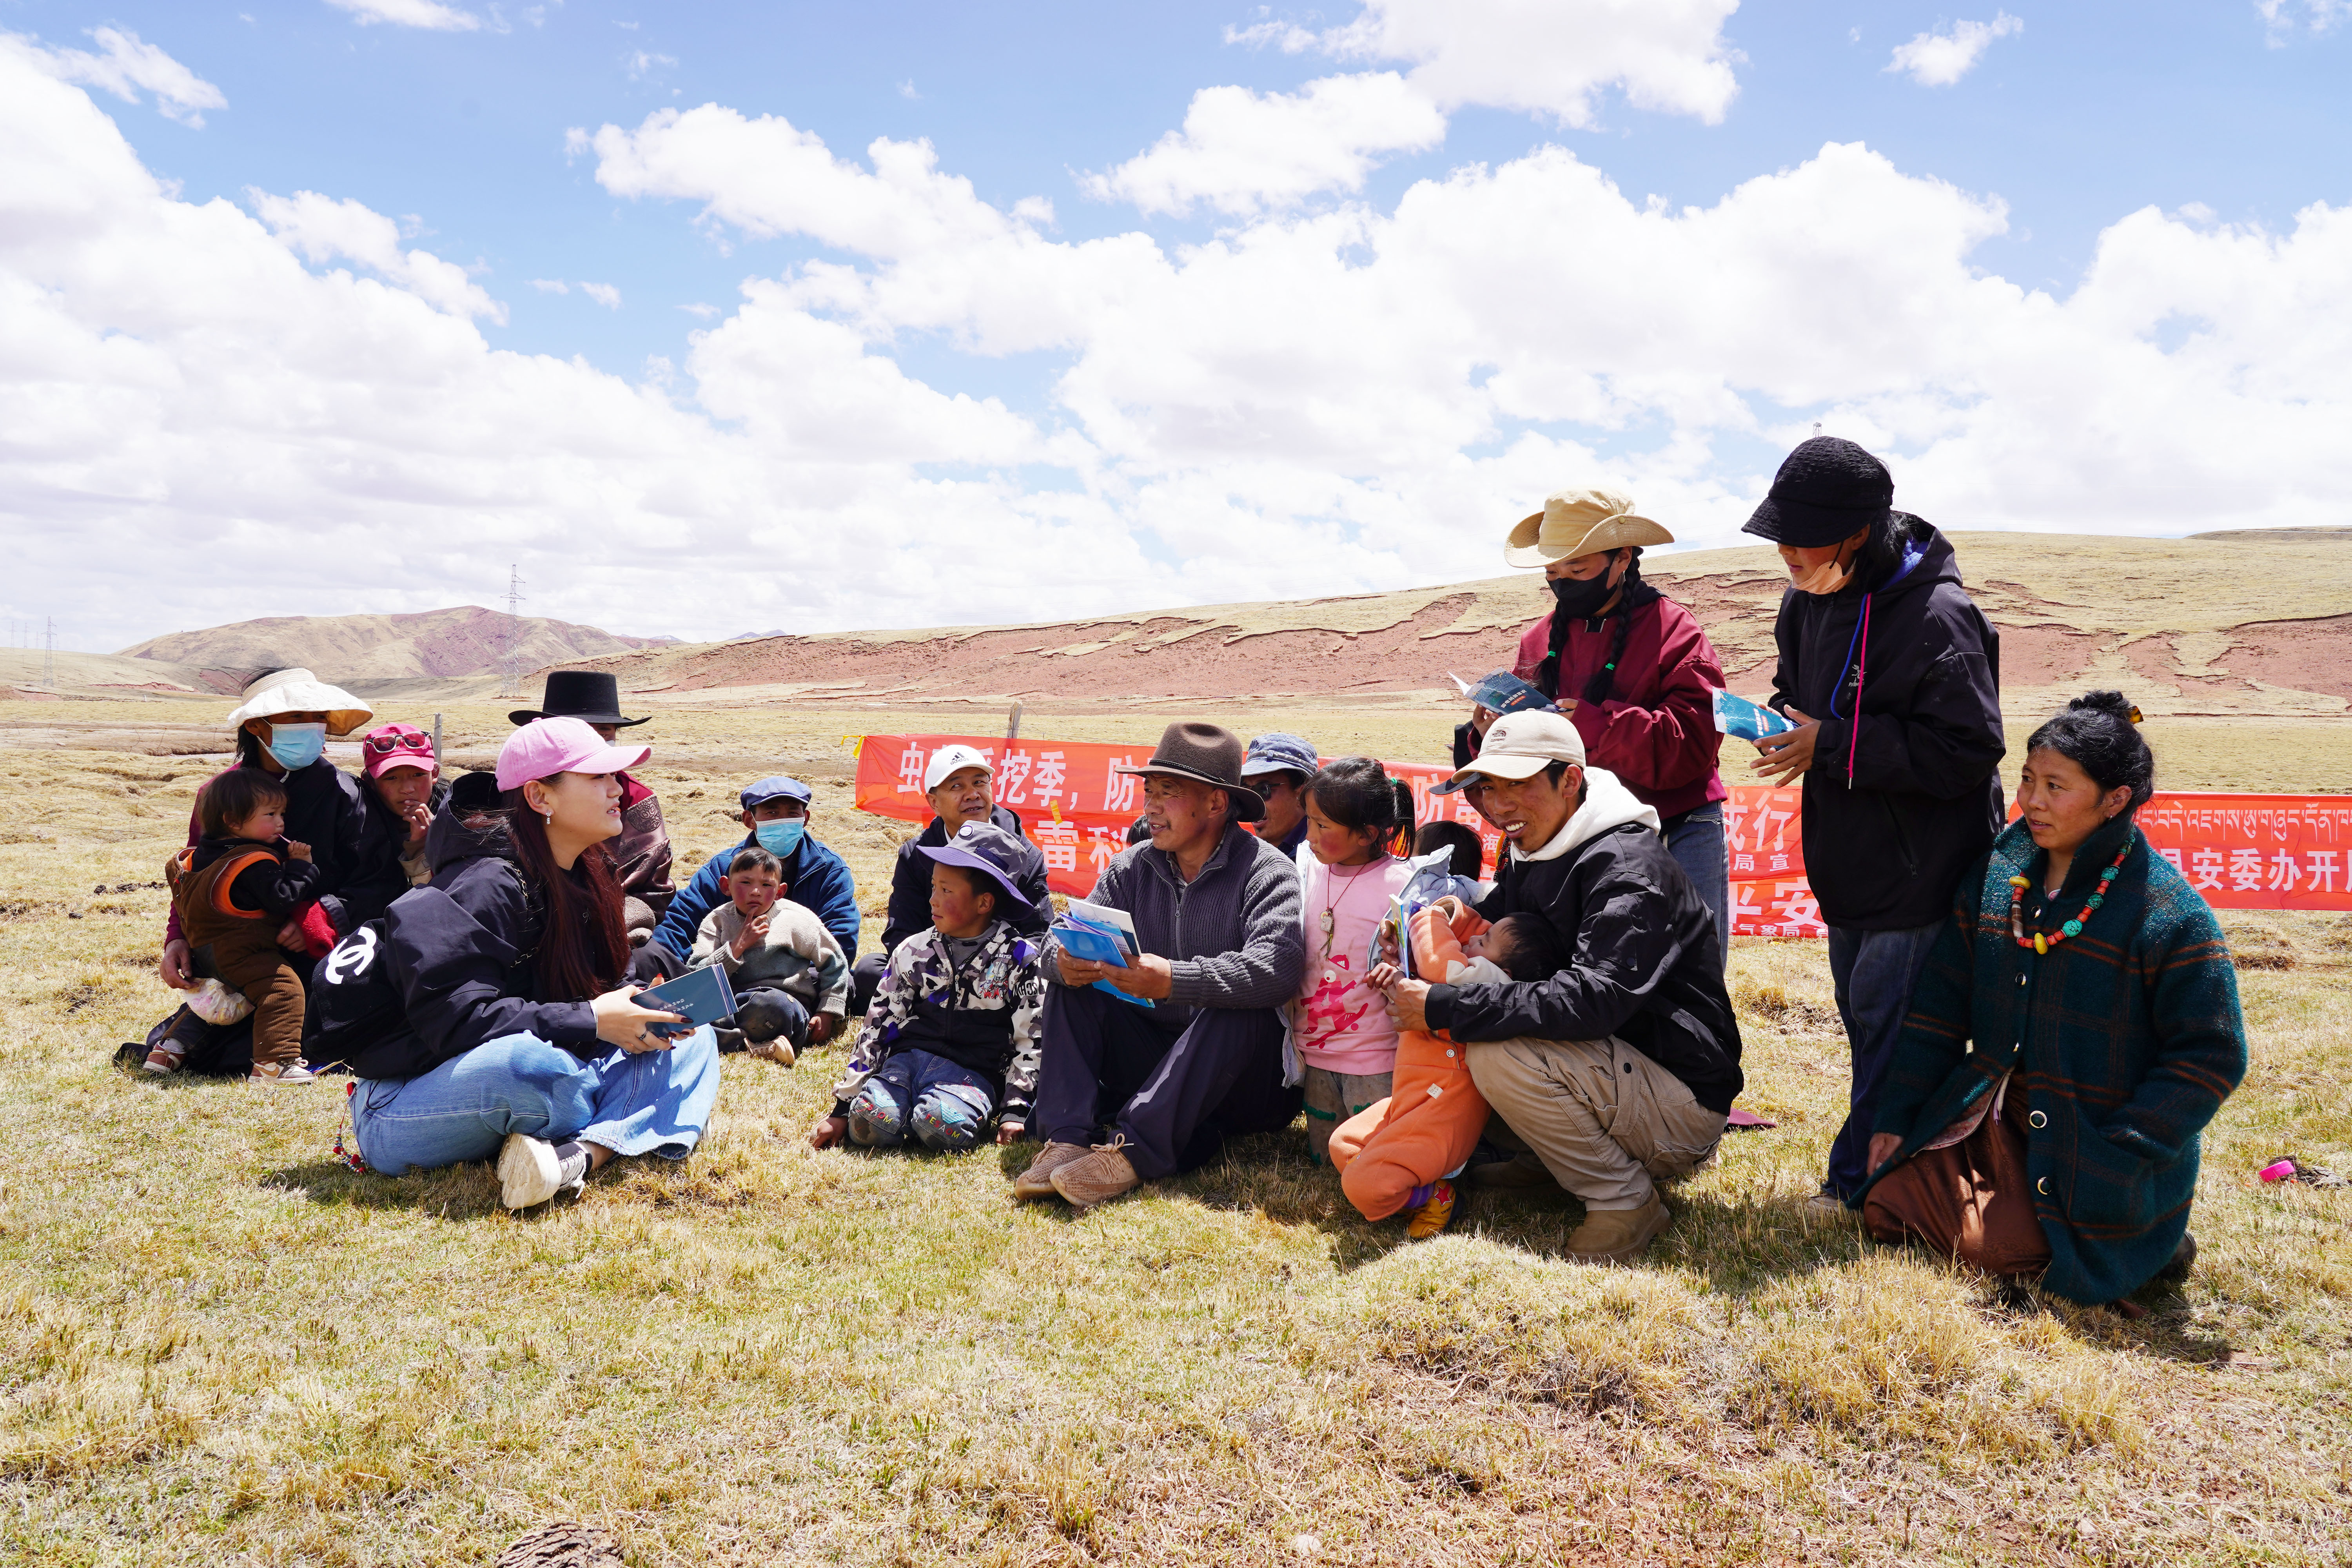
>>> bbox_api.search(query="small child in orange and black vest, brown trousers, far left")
[146,769,332,1084]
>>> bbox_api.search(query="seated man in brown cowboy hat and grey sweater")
[1014,724,1308,1208]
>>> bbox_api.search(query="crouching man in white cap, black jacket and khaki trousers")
[1390,712,1740,1262]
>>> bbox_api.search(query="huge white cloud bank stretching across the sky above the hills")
[0,47,2352,644]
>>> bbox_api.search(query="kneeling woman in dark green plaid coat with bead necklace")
[1851,691,2246,1305]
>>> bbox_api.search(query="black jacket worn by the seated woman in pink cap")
[346,806,604,1079]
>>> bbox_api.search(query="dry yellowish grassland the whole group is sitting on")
[0,703,2352,1566]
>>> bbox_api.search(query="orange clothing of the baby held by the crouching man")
[1331,910,1486,1220]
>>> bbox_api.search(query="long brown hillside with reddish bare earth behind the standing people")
[546,529,2352,717]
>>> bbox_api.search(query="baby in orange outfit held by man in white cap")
[1331,898,1548,1239]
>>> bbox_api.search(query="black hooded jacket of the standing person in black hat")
[1771,512,2006,931]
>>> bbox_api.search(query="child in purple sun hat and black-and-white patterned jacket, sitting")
[809,823,1044,1152]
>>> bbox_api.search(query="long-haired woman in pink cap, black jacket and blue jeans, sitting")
[327,719,720,1208]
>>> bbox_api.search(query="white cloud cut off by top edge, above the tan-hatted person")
[1327,0,1740,127]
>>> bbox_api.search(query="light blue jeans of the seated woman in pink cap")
[350,1030,720,1176]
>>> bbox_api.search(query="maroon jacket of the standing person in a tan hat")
[1512,597,1729,818]
